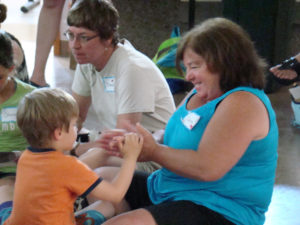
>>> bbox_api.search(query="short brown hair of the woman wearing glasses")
[67,0,119,45]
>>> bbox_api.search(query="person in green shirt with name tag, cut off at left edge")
[0,31,34,208]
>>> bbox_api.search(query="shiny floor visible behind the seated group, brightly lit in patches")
[2,0,300,225]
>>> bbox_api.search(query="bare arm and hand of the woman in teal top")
[137,92,269,181]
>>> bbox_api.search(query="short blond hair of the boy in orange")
[17,88,79,148]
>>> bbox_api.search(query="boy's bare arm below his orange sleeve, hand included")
[91,133,143,203]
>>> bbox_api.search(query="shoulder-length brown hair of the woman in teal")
[176,18,266,92]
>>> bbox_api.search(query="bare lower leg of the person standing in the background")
[30,0,65,86]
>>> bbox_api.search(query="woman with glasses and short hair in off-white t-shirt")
[65,0,175,171]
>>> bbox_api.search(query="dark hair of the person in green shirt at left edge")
[0,30,14,69]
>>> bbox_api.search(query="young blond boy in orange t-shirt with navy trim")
[4,88,143,225]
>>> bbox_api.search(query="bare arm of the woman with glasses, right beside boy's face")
[72,92,91,131]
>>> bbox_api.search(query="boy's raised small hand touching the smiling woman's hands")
[117,133,143,158]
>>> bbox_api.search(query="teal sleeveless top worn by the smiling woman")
[147,87,278,225]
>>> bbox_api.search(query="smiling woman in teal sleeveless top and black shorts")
[102,18,278,225]
